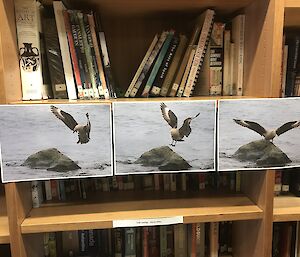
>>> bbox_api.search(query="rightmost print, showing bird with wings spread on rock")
[218,98,300,170]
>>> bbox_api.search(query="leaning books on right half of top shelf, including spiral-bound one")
[125,9,245,97]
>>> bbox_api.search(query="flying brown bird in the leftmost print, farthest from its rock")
[50,105,91,144]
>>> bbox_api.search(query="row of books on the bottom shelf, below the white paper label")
[44,222,232,257]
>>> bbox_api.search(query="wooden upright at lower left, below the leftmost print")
[5,183,33,257]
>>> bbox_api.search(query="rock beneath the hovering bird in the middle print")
[135,146,192,171]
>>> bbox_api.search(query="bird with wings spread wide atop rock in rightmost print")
[233,119,300,143]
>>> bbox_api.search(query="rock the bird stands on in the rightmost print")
[233,139,292,167]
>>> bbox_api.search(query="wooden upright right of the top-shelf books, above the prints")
[244,0,284,97]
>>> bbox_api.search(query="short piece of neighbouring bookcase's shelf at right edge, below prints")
[273,195,300,222]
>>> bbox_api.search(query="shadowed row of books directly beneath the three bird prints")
[32,172,241,208]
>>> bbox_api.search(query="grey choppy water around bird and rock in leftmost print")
[0,105,112,181]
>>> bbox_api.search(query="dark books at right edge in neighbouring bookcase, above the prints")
[281,29,300,97]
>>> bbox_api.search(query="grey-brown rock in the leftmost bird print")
[22,148,81,172]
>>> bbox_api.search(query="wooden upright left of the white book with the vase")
[0,0,22,103]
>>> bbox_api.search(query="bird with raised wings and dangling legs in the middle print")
[160,103,200,146]
